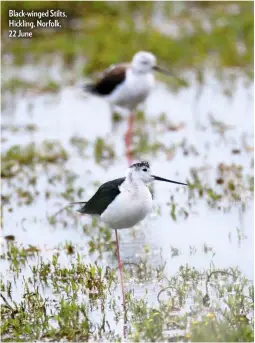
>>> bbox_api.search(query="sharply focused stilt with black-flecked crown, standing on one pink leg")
[72,161,187,338]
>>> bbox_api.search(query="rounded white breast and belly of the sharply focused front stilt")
[101,186,152,229]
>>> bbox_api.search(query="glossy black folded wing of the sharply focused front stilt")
[78,177,125,215]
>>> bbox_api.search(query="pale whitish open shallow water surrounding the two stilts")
[1,70,253,301]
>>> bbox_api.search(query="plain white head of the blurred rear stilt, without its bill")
[131,51,157,74]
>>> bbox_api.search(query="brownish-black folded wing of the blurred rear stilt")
[85,63,127,95]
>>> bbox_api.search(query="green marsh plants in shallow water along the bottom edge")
[1,242,254,342]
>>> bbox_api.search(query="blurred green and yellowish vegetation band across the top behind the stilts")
[2,1,254,90]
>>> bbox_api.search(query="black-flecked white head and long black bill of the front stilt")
[127,161,187,185]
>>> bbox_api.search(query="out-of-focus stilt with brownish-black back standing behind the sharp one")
[84,51,170,162]
